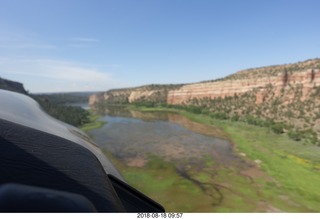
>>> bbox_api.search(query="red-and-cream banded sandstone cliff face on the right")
[167,69,320,105]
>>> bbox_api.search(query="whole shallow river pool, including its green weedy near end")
[89,107,267,212]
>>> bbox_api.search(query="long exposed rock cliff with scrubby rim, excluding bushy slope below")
[89,59,320,106]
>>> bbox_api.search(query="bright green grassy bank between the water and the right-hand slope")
[119,107,320,212]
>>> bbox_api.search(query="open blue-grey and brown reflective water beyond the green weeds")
[90,107,232,165]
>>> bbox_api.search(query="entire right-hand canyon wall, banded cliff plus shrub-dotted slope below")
[90,59,320,140]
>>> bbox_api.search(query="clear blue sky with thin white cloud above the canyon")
[0,0,320,93]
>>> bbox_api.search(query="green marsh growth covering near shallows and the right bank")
[103,106,320,212]
